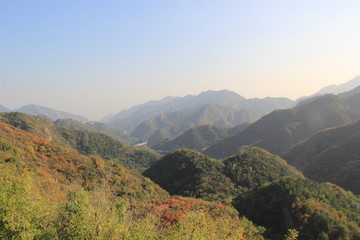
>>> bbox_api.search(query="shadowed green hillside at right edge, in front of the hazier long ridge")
[282,121,360,194]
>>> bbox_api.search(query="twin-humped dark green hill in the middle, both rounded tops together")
[144,148,302,202]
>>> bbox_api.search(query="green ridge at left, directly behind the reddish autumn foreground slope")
[0,113,160,171]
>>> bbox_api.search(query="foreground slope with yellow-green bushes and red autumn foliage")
[0,122,262,240]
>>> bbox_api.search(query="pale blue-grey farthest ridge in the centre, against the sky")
[107,90,294,132]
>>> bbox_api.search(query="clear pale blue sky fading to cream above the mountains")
[0,0,360,120]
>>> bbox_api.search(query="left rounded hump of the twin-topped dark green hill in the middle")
[144,149,239,201]
